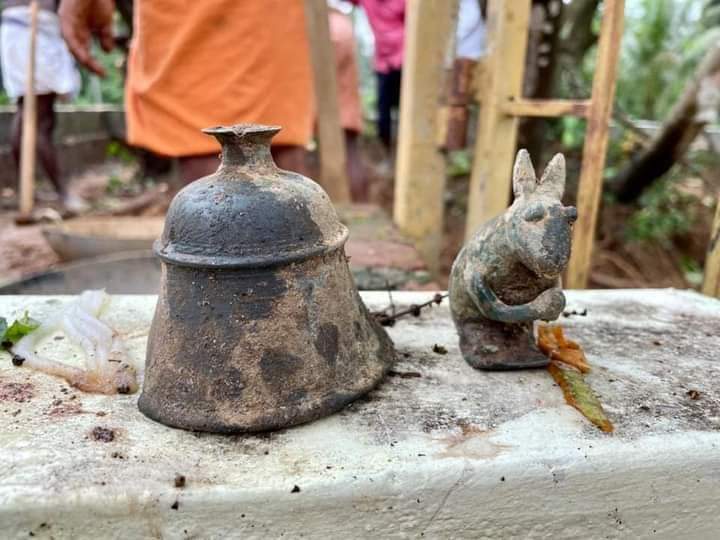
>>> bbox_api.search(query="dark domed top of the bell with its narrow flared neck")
[155,124,348,268]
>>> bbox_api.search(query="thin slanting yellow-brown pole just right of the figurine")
[566,0,625,289]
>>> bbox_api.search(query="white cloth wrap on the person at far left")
[0,6,80,99]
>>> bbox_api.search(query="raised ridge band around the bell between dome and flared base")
[153,224,349,269]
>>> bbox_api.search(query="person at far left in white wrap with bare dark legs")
[0,0,83,210]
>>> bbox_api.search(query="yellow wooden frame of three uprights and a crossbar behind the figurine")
[394,0,624,288]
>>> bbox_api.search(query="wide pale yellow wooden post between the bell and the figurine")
[394,0,457,273]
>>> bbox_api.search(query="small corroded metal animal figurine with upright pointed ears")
[450,150,577,370]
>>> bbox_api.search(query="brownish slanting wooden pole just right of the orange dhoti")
[302,0,350,203]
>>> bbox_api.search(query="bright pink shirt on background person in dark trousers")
[351,0,405,73]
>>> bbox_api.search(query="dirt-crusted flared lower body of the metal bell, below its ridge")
[138,249,395,433]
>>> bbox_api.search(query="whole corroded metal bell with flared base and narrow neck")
[139,125,394,433]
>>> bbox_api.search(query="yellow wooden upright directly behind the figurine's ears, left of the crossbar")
[465,0,530,238]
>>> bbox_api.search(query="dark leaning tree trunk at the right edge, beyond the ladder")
[612,44,720,203]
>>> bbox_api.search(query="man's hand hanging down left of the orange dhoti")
[58,0,115,77]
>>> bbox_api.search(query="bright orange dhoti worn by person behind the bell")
[125,0,314,156]
